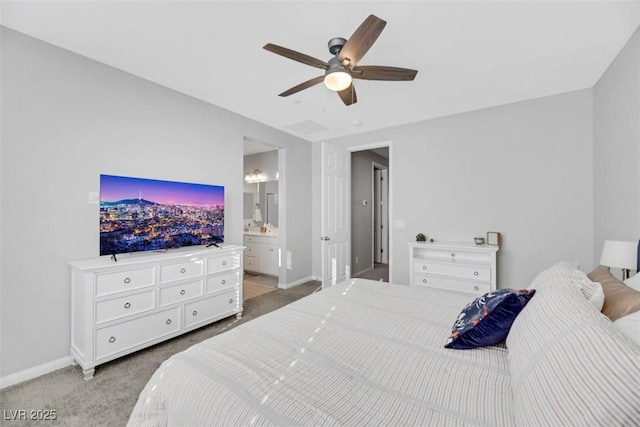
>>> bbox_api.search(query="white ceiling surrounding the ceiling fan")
[0,0,640,141]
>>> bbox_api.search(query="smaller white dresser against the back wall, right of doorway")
[409,242,498,295]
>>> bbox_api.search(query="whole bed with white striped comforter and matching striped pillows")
[129,263,640,426]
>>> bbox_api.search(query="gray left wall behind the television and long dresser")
[0,28,311,377]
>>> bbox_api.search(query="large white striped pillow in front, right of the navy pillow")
[506,284,640,426]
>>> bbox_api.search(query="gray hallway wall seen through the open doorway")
[351,150,389,274]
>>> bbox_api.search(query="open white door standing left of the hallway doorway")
[320,142,351,288]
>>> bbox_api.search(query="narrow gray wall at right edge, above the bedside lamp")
[593,30,640,263]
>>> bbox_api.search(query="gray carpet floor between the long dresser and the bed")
[0,281,320,427]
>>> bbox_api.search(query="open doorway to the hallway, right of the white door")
[351,146,390,282]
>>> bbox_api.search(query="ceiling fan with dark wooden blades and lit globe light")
[263,15,418,105]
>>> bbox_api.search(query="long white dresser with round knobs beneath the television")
[69,246,244,380]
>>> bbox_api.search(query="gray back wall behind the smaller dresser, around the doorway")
[313,90,593,287]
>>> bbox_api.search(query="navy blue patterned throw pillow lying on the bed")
[445,289,536,349]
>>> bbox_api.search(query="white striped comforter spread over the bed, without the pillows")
[129,279,513,426]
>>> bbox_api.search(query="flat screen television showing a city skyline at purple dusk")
[100,175,224,255]
